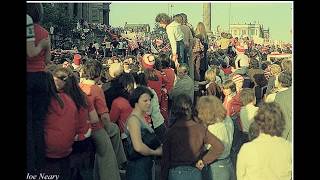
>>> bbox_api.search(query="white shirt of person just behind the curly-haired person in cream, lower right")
[240,104,259,132]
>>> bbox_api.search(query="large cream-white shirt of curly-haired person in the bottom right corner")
[237,133,292,180]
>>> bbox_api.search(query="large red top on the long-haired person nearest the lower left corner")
[44,93,79,158]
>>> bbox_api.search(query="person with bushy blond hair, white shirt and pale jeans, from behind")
[196,96,235,180]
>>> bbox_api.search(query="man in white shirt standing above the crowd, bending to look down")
[156,13,187,67]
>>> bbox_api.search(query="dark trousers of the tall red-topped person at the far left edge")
[27,72,50,172]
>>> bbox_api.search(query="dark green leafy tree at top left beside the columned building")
[42,3,76,38]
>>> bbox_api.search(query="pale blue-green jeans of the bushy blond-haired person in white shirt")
[203,158,236,180]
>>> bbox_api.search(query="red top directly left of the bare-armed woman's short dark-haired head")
[110,97,132,133]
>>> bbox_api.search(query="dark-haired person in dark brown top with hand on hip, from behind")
[161,94,224,180]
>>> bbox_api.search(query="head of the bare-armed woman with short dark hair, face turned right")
[129,86,153,112]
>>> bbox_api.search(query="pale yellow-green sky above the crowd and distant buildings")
[109,1,293,42]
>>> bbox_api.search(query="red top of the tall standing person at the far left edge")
[27,24,49,72]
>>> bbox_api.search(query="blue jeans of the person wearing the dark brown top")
[168,166,202,180]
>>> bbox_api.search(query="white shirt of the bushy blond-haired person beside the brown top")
[207,116,234,159]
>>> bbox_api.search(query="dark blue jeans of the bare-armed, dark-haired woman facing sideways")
[126,156,153,180]
